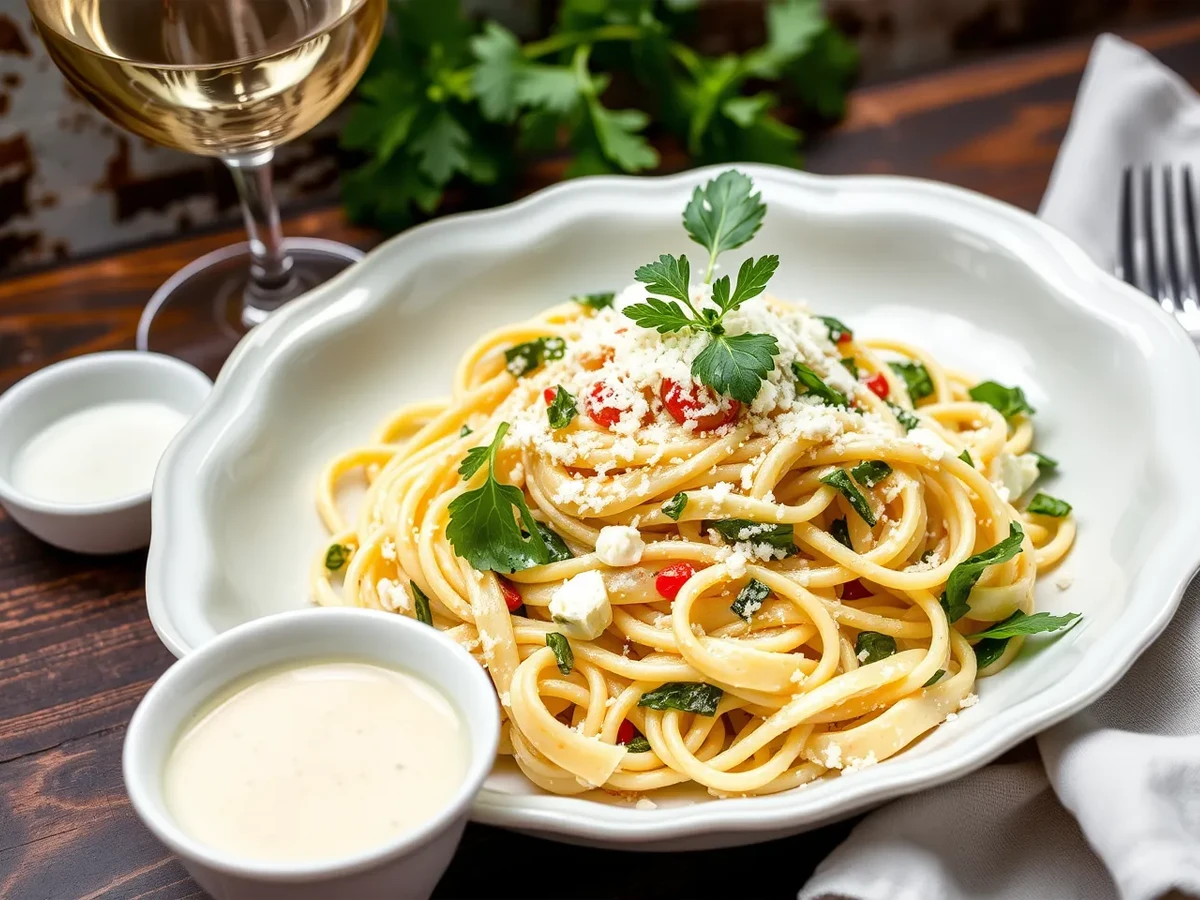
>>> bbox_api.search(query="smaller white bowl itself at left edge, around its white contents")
[0,350,212,553]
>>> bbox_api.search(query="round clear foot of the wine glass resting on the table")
[137,238,362,378]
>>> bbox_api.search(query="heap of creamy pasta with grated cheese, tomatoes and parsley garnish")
[311,170,1078,804]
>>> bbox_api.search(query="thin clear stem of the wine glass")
[221,149,295,325]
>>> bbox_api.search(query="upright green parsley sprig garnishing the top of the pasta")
[624,169,779,403]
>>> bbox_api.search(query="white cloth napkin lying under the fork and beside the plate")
[799,35,1200,900]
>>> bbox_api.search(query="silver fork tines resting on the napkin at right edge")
[1117,164,1200,341]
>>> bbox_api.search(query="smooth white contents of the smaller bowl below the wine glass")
[12,401,187,503]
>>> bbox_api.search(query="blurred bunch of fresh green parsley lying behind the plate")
[341,0,858,229]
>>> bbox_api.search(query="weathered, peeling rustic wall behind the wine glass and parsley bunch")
[0,0,1200,272]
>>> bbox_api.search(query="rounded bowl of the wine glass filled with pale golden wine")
[29,0,386,156]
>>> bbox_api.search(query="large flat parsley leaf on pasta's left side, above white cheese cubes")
[446,422,550,572]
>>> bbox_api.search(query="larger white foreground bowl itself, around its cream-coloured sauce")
[122,608,500,900]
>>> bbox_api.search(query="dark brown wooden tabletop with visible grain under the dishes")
[0,18,1200,900]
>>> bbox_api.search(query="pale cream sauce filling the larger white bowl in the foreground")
[163,661,469,862]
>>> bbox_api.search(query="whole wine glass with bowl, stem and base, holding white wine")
[29,0,388,374]
